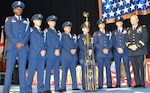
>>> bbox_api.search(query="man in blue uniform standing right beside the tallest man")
[26,14,46,93]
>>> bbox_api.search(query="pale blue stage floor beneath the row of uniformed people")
[0,85,150,93]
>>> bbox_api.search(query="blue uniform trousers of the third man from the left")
[45,57,60,90]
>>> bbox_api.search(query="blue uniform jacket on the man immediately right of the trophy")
[94,31,112,58]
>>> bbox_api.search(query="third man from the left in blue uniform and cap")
[45,15,61,93]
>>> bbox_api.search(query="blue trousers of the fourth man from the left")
[61,59,77,89]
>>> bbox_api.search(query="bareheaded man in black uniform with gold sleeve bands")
[126,15,148,88]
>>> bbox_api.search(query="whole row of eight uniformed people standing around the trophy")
[3,1,148,93]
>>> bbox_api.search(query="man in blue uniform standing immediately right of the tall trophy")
[94,19,112,89]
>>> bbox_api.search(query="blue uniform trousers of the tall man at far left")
[3,49,27,93]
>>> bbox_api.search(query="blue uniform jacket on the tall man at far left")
[5,16,30,50]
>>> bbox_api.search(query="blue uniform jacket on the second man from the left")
[30,27,47,58]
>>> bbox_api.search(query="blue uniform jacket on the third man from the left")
[46,28,62,58]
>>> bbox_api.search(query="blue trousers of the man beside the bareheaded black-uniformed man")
[114,55,131,86]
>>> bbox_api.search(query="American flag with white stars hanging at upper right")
[98,0,150,23]
